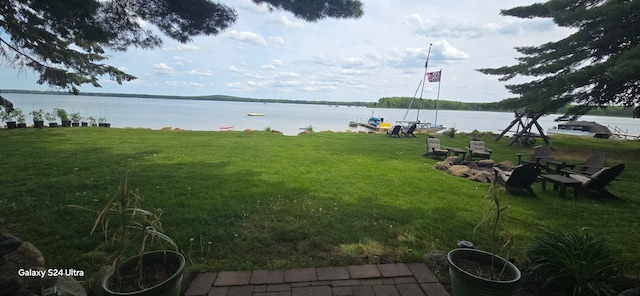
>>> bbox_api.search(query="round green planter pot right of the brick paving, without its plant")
[447,249,521,296]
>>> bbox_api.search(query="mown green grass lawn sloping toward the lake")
[0,128,640,275]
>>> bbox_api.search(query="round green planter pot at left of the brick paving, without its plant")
[102,251,185,296]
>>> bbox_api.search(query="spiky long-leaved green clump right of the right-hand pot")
[527,230,622,296]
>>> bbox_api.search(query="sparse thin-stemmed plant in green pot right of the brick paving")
[447,180,521,296]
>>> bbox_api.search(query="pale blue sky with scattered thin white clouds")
[0,0,571,102]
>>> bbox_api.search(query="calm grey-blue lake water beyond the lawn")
[2,93,640,135]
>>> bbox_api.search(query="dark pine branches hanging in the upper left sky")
[0,0,363,94]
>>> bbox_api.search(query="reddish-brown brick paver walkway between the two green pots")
[184,263,449,296]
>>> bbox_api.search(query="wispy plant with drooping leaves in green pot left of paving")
[77,173,185,296]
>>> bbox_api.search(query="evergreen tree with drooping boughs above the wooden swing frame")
[478,0,640,118]
